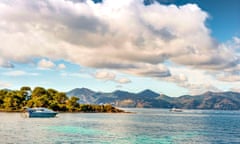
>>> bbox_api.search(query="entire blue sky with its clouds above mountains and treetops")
[0,0,240,97]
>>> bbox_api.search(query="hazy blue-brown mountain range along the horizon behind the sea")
[66,88,240,110]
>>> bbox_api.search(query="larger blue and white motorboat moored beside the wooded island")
[23,107,58,118]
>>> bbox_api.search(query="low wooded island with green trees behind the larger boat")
[0,86,125,113]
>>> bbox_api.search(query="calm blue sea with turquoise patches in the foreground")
[0,108,240,144]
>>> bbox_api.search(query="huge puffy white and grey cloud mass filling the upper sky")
[0,0,239,79]
